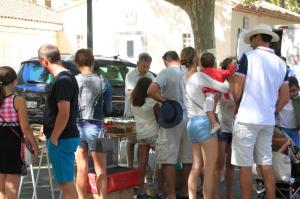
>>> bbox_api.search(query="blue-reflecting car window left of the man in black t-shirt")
[19,62,53,84]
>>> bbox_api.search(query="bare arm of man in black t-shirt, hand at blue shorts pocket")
[50,100,70,145]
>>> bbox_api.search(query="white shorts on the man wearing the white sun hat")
[231,122,274,166]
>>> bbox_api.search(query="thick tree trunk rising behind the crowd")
[166,0,216,53]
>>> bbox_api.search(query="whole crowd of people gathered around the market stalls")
[0,24,300,199]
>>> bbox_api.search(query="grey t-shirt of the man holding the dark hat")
[154,65,187,110]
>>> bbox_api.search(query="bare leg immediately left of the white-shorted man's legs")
[225,144,234,199]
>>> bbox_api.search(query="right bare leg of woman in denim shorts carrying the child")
[202,138,219,199]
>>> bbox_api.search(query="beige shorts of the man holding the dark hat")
[156,114,192,164]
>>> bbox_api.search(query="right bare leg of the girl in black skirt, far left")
[5,174,20,199]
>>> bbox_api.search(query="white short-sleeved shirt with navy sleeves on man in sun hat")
[235,46,288,126]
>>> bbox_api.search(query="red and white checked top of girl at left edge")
[0,95,19,123]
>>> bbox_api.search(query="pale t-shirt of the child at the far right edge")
[277,99,297,129]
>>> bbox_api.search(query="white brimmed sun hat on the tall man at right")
[244,24,279,44]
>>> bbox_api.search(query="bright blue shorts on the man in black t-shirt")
[47,137,79,184]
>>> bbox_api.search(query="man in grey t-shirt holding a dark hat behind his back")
[148,51,192,199]
